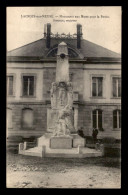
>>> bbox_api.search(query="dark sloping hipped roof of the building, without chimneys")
[7,38,121,59]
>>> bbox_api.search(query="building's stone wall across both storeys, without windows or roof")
[7,62,121,137]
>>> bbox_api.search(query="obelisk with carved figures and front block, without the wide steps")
[50,42,75,149]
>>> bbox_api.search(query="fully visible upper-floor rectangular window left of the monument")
[23,76,34,96]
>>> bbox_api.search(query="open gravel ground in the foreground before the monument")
[6,152,121,188]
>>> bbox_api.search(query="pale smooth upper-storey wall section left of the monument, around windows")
[7,63,44,102]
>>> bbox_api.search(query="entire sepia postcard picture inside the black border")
[6,6,122,189]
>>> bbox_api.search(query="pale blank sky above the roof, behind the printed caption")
[6,6,122,53]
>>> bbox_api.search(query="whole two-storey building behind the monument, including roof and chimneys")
[7,24,121,139]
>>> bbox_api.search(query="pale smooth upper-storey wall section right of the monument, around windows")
[83,64,121,104]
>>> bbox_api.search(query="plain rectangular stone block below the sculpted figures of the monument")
[50,136,73,149]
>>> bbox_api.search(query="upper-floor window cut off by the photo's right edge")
[112,77,121,97]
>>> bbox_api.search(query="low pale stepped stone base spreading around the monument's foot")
[19,134,102,158]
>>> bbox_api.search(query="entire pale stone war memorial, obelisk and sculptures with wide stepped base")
[19,42,94,158]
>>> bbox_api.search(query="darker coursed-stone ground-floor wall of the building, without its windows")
[8,104,121,139]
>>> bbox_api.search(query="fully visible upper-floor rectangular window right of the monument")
[92,77,103,97]
